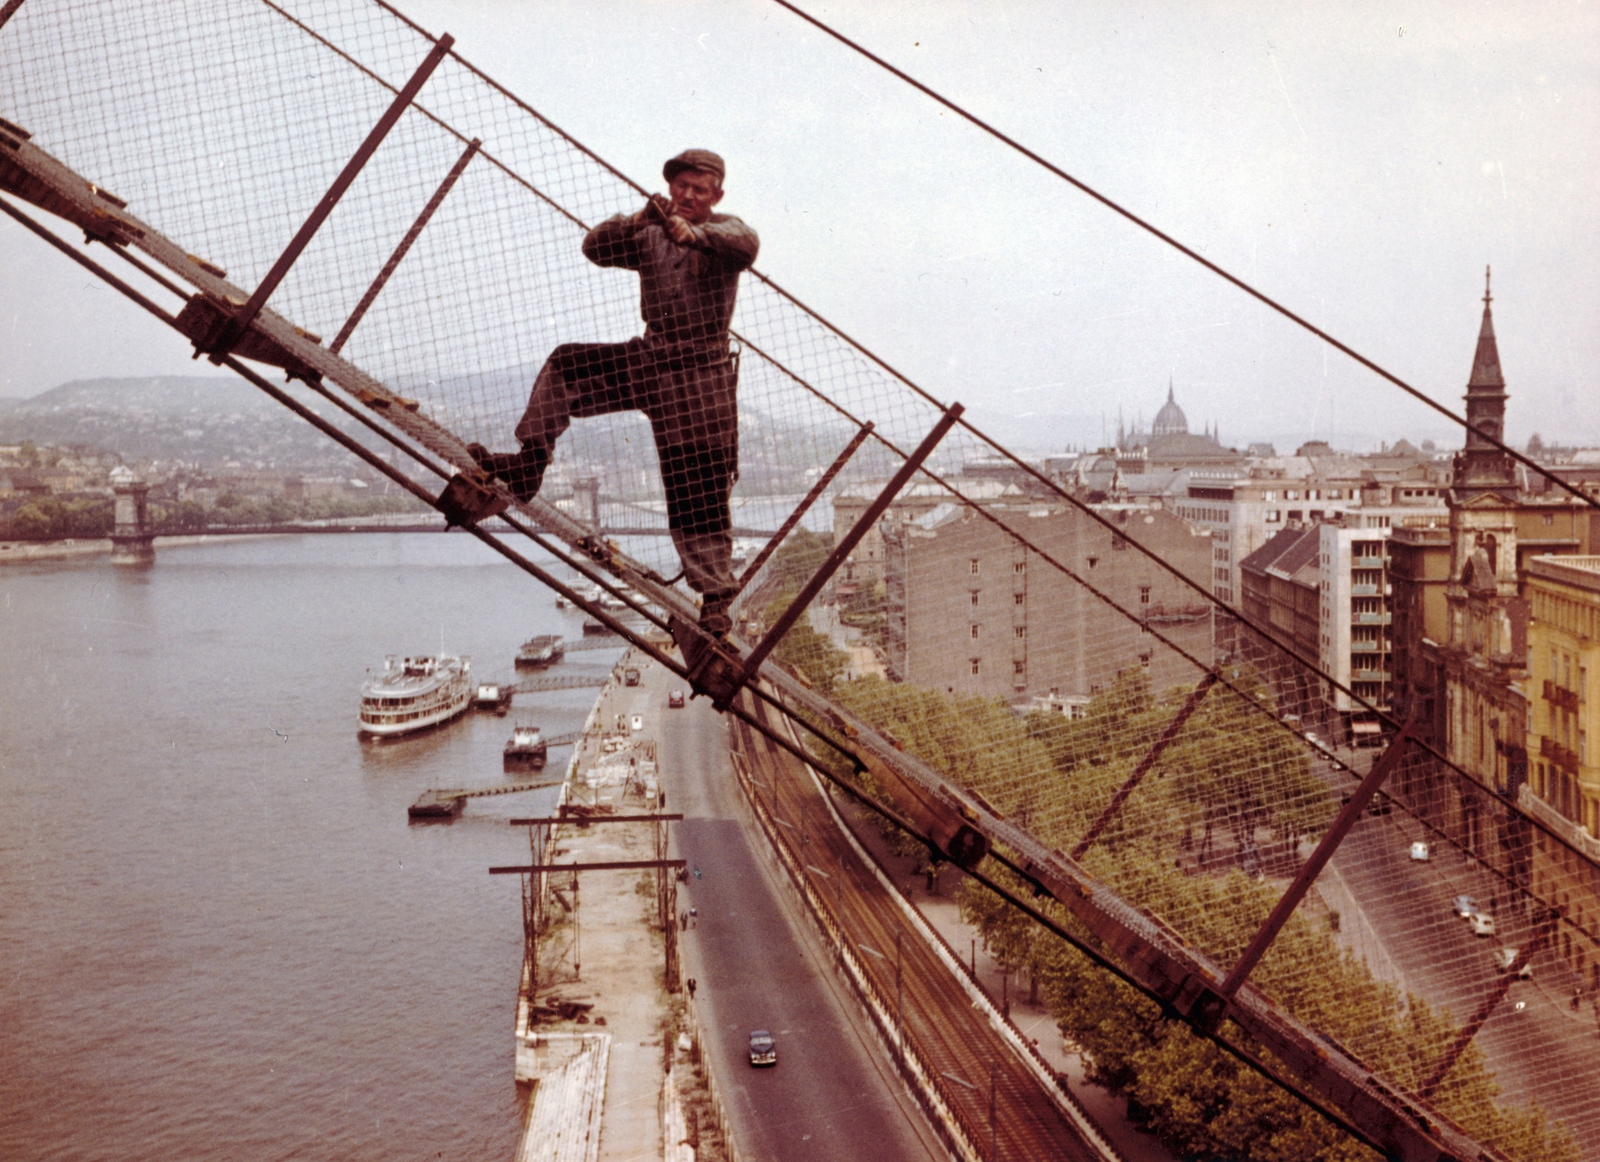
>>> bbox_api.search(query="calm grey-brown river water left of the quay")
[0,535,618,1162]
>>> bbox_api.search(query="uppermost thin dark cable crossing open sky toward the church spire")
[773,0,1600,509]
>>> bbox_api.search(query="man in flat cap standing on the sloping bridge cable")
[469,149,760,637]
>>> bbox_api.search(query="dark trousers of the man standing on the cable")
[517,332,739,595]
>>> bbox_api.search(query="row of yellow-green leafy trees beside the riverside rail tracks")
[784,672,1578,1162]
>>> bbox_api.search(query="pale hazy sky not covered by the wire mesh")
[0,0,1600,450]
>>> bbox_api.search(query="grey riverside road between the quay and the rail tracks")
[611,664,946,1162]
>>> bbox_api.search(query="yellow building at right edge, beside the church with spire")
[1520,557,1600,989]
